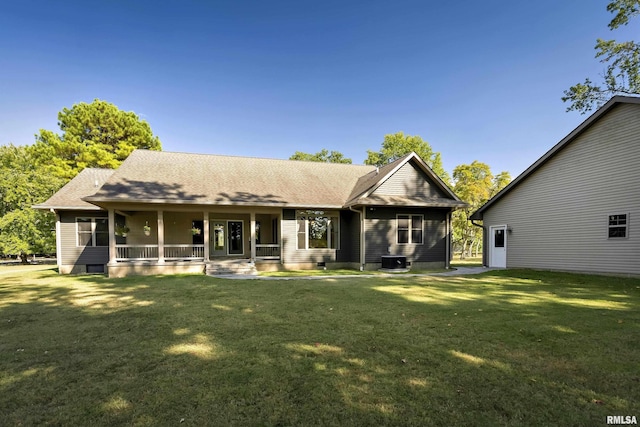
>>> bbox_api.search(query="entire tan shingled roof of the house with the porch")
[39,150,463,209]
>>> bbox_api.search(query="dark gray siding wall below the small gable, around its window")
[365,208,447,263]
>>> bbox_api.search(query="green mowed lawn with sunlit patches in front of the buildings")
[0,267,640,426]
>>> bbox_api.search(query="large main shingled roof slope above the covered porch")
[85,150,375,208]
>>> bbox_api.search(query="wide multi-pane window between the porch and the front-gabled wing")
[296,210,340,249]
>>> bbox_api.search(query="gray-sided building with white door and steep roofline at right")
[471,96,640,275]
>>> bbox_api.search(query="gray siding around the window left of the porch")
[57,211,109,265]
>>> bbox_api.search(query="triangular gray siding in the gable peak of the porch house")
[372,162,449,198]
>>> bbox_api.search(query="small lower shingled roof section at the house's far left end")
[34,168,115,210]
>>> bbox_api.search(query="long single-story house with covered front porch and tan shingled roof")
[36,150,465,277]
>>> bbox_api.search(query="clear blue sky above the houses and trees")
[0,0,638,177]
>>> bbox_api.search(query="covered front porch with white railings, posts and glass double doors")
[108,209,282,275]
